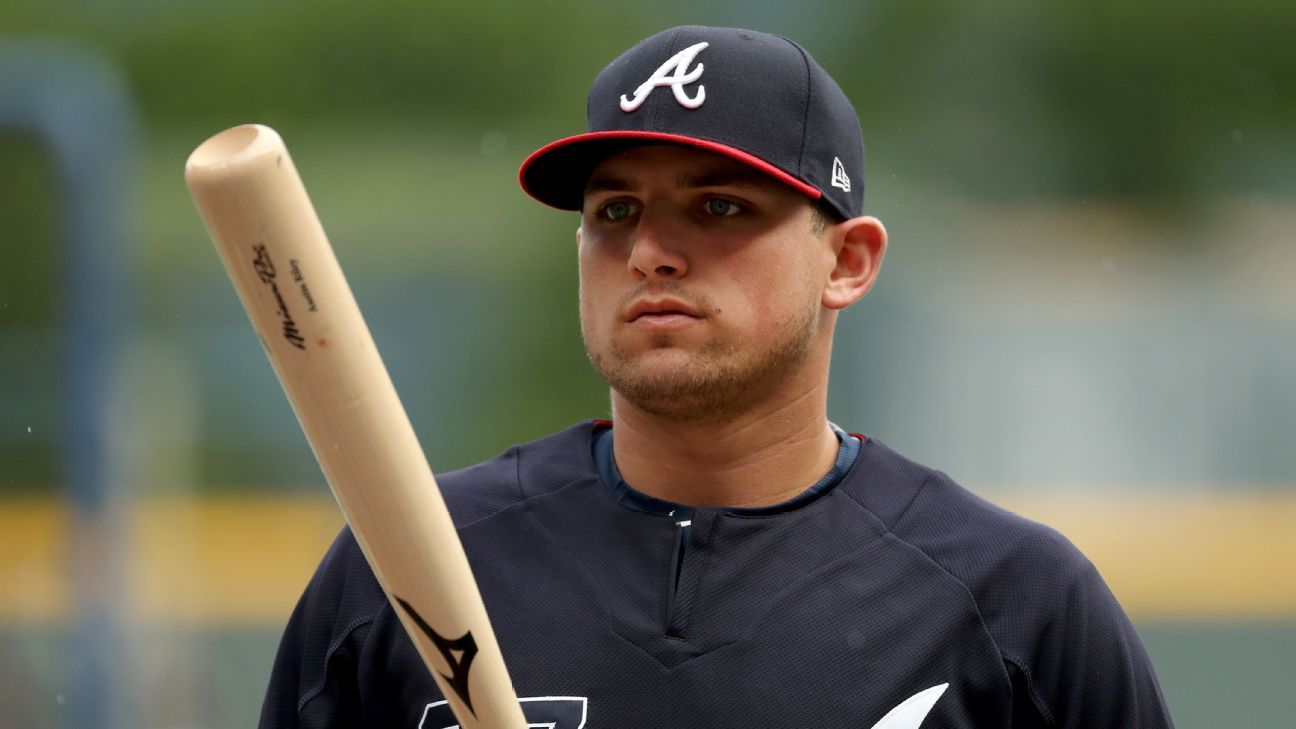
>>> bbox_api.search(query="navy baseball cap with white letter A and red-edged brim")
[518,26,864,219]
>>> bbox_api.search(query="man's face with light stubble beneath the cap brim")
[579,145,835,422]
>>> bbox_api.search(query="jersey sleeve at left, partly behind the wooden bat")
[259,528,386,729]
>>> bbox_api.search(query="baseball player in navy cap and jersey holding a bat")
[262,27,1172,729]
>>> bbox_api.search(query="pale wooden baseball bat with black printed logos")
[184,125,526,729]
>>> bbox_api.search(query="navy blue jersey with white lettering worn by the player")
[262,423,1172,729]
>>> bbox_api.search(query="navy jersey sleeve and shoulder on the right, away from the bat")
[857,442,1173,729]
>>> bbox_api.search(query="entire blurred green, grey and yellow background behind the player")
[0,0,1296,729]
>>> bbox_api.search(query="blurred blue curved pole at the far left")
[0,39,136,729]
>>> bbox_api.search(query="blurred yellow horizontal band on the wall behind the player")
[0,489,1296,627]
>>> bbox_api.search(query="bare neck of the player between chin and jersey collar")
[612,360,839,507]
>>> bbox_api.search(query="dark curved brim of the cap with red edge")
[517,131,823,210]
